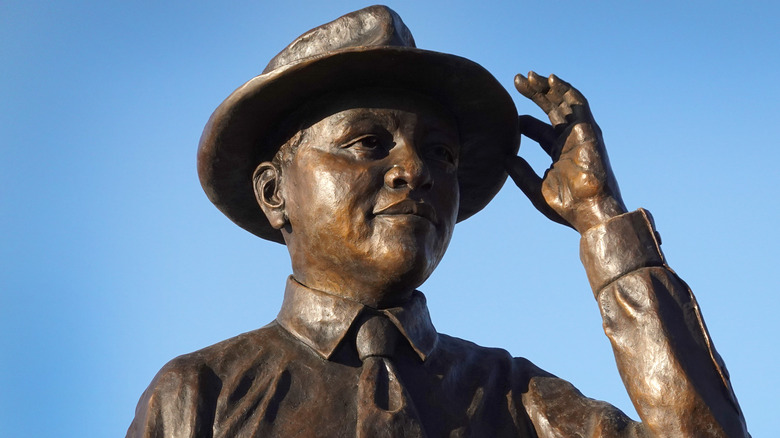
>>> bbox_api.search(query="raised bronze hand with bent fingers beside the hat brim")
[506,72,626,233]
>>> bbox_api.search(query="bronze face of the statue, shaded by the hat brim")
[279,91,460,306]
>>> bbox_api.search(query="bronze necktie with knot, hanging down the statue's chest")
[356,315,425,438]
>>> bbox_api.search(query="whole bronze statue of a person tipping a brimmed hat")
[128,6,749,437]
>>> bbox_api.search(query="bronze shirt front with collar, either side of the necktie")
[128,278,556,437]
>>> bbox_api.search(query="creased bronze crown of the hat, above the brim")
[263,5,416,73]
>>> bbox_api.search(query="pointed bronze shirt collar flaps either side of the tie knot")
[276,276,438,361]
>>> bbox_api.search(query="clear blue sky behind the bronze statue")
[0,0,780,437]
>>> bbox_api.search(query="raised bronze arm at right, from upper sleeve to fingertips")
[507,72,749,437]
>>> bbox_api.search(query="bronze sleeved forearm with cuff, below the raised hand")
[581,210,748,437]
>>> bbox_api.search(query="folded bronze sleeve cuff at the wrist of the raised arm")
[580,208,666,294]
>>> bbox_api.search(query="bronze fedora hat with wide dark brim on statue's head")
[198,6,520,243]
